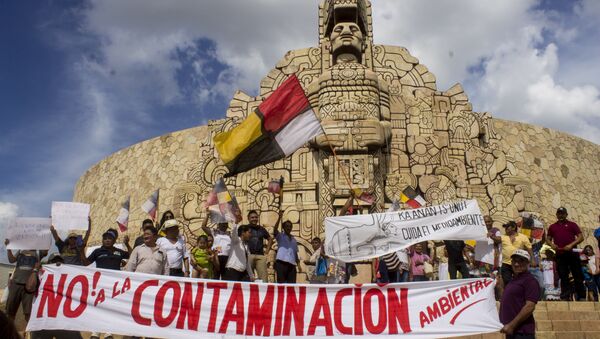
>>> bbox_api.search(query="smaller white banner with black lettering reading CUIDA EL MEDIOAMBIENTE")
[325,200,487,262]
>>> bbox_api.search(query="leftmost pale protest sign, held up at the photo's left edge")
[6,218,52,250]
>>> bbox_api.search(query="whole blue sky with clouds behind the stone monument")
[0,0,600,223]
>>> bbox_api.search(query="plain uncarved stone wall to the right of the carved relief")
[494,119,600,244]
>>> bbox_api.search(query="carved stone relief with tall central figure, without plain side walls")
[173,0,537,280]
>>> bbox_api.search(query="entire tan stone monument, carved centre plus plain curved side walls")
[75,0,600,280]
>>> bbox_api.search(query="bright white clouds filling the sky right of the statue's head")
[373,0,600,143]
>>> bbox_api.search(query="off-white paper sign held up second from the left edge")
[51,201,90,232]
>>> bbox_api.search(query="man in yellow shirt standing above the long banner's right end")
[500,221,537,286]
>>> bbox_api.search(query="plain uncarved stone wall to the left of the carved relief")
[73,126,207,245]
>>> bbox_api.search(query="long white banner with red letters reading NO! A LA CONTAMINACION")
[27,265,502,338]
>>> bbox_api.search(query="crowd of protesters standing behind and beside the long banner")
[5,190,600,338]
